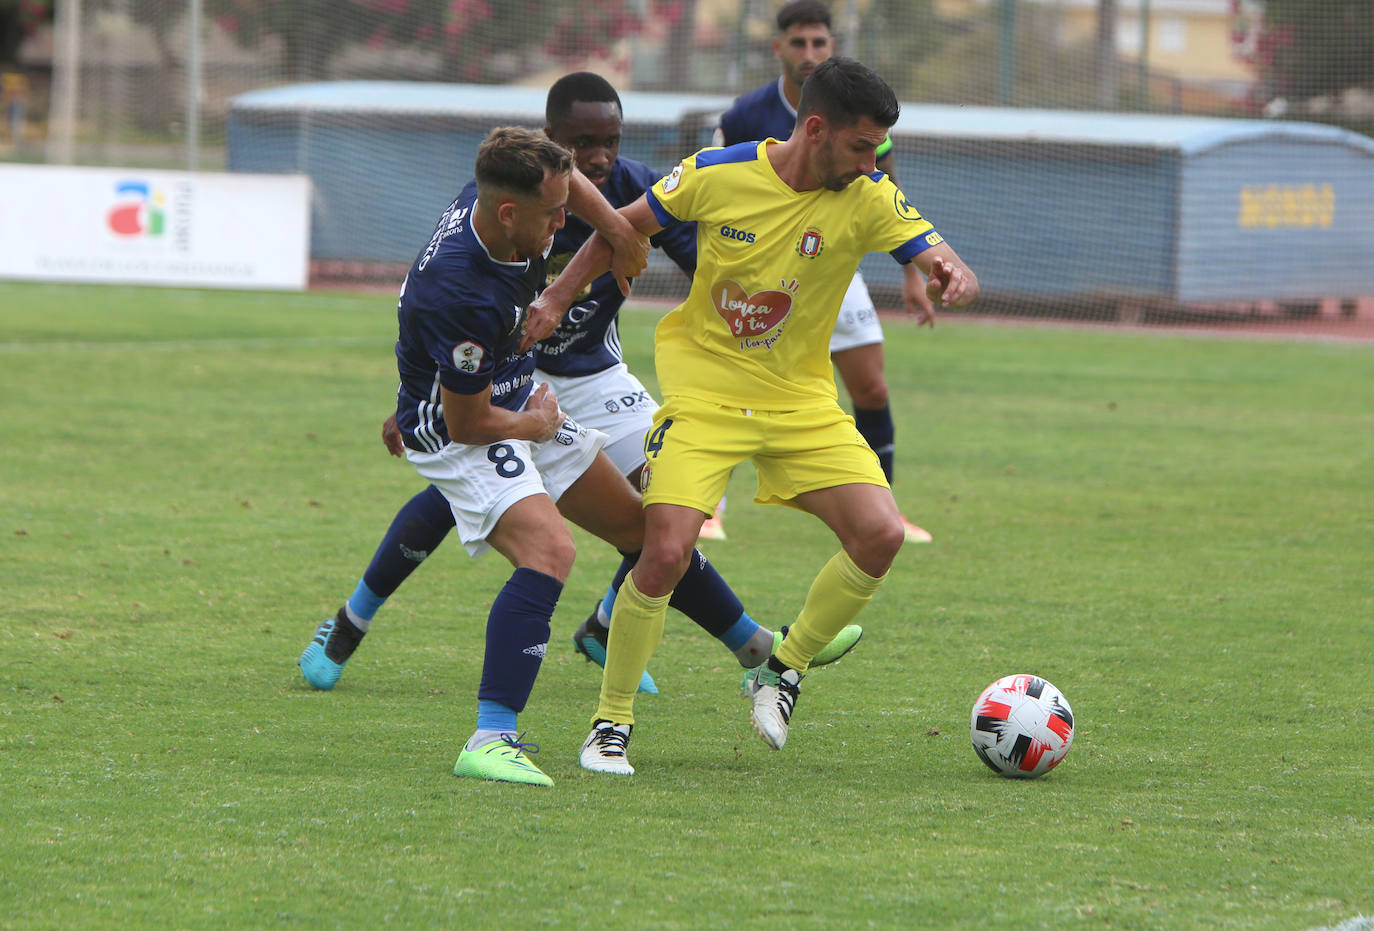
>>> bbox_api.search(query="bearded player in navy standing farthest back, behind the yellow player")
[702,0,936,542]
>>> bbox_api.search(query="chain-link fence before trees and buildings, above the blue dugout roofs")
[4,0,1341,168]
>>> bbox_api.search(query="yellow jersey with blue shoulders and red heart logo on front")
[647,139,943,411]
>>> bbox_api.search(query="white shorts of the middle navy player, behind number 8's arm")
[534,363,658,475]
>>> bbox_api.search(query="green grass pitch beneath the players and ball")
[0,284,1374,928]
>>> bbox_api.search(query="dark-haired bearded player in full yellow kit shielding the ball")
[526,58,978,773]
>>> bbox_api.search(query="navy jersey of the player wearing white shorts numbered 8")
[396,181,545,453]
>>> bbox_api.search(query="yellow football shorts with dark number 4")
[640,398,888,514]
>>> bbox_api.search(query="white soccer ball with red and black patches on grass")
[969,676,1073,779]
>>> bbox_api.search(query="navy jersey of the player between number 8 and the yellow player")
[534,158,697,376]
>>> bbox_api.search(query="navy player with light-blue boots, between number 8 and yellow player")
[300,73,861,785]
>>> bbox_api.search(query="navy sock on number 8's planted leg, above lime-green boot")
[477,568,563,713]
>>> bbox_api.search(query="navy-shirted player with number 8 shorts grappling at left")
[354,128,647,785]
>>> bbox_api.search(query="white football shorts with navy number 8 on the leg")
[405,398,606,558]
